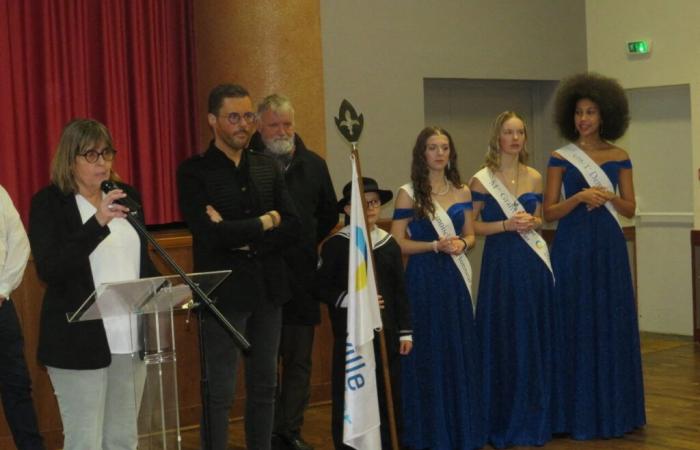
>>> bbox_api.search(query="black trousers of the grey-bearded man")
[275,325,316,437]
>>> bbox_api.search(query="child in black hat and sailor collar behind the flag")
[317,177,413,449]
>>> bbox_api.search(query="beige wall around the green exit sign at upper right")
[586,0,700,228]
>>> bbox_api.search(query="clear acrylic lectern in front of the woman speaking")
[68,270,231,450]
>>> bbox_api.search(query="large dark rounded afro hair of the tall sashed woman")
[554,73,630,141]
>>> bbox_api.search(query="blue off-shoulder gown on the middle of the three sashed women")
[472,192,553,448]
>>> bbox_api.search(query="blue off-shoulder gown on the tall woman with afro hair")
[549,157,646,439]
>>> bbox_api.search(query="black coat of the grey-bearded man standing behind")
[250,133,338,325]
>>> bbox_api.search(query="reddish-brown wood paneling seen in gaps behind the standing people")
[0,230,333,450]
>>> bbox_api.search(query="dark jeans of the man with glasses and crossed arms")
[201,301,282,450]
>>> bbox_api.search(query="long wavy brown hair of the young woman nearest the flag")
[411,126,462,218]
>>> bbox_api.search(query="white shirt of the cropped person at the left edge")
[0,186,29,298]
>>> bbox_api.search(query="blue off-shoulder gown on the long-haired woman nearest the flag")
[394,202,484,450]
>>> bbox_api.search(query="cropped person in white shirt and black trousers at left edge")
[0,186,44,450]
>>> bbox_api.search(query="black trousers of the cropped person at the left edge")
[0,299,45,450]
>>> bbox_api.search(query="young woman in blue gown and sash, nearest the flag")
[391,127,484,450]
